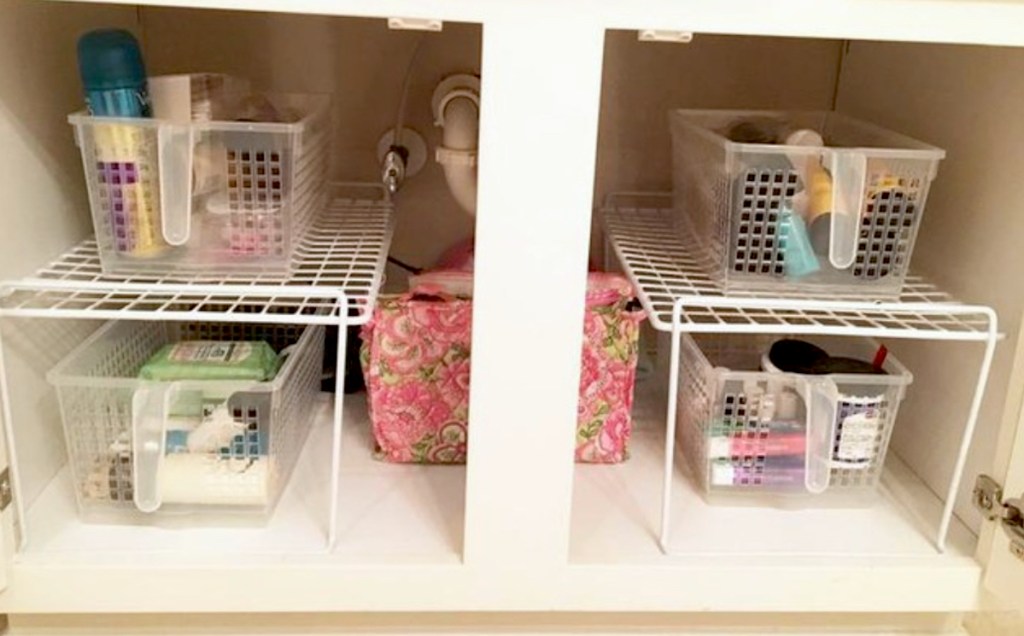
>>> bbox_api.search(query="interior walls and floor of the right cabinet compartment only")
[585,31,1024,561]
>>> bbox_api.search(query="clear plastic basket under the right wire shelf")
[678,334,913,506]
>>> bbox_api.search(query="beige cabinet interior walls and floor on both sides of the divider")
[0,1,1024,563]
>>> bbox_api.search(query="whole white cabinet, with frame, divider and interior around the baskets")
[0,0,1024,613]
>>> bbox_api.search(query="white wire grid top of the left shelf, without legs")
[0,185,393,325]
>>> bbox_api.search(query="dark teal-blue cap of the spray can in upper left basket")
[78,29,145,92]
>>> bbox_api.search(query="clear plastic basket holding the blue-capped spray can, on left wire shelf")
[68,94,330,275]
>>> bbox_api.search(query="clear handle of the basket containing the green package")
[131,383,178,512]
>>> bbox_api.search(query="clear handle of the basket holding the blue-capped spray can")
[157,124,196,246]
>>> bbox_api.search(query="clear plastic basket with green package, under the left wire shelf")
[47,321,324,522]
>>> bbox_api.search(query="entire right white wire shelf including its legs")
[601,193,999,554]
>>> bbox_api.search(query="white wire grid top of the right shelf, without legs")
[602,194,990,341]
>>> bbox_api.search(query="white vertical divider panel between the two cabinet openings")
[464,14,604,567]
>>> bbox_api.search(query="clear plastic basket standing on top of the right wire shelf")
[671,111,945,298]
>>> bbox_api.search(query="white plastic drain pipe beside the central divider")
[437,95,479,214]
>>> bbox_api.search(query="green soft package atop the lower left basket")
[138,340,280,382]
